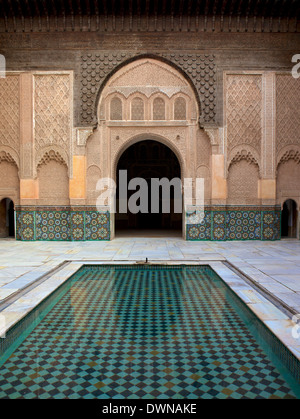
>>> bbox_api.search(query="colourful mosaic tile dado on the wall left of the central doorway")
[16,207,110,241]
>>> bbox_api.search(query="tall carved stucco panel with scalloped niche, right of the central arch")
[225,74,263,205]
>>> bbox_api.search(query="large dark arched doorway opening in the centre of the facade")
[115,140,182,235]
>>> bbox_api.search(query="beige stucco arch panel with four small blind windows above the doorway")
[93,58,202,189]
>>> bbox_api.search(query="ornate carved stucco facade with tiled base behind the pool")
[0,0,300,240]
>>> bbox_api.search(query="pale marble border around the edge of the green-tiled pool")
[0,259,300,368]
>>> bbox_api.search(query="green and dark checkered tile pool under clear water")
[0,266,300,399]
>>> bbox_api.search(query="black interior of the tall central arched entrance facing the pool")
[115,140,182,236]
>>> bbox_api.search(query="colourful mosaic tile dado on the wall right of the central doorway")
[186,207,281,241]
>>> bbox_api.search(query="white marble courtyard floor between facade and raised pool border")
[0,235,300,313]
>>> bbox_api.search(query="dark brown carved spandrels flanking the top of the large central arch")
[76,52,217,127]
